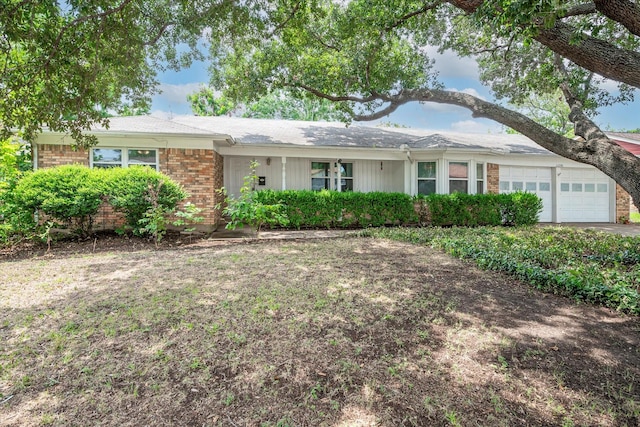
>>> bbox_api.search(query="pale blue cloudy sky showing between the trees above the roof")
[151,48,640,133]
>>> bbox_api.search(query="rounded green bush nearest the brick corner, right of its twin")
[104,166,187,234]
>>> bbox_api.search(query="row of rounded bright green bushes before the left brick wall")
[2,165,187,234]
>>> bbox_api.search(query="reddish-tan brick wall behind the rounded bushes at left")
[38,145,224,229]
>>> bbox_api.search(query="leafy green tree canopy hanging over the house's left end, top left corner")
[0,0,238,146]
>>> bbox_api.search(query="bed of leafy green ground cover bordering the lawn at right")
[363,227,640,314]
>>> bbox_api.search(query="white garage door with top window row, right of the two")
[558,169,611,222]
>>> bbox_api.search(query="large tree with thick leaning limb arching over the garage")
[212,0,640,210]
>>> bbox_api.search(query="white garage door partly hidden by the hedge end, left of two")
[500,166,553,222]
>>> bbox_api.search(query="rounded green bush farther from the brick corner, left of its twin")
[7,165,105,233]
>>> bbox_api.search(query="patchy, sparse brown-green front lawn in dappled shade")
[0,237,640,427]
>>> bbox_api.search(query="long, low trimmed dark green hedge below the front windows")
[254,190,542,229]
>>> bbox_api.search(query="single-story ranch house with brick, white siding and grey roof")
[34,116,640,227]
